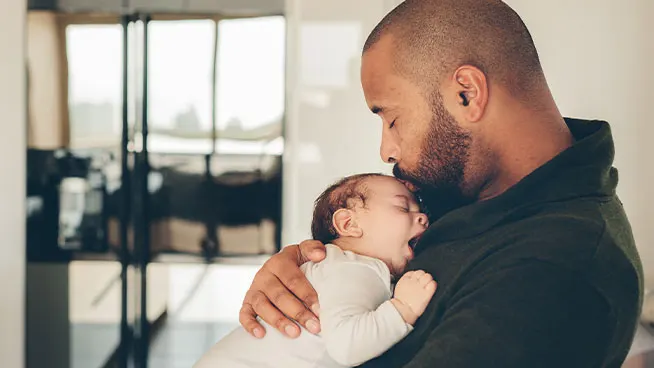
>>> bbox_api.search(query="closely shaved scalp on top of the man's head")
[363,0,545,100]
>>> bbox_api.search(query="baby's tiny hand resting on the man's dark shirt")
[391,270,436,325]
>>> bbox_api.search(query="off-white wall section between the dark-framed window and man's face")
[282,0,400,244]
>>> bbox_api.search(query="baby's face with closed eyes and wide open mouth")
[356,176,429,275]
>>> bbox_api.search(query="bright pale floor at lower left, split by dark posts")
[66,255,267,368]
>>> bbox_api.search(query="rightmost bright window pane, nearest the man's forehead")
[217,16,286,139]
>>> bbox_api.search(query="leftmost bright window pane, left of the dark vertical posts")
[66,24,123,148]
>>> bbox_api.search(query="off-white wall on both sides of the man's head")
[283,0,654,287]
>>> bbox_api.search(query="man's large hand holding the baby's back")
[239,240,325,338]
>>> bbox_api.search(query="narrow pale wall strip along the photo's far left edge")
[0,0,27,368]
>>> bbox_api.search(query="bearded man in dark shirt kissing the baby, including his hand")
[240,0,643,368]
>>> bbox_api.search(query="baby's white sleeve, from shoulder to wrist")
[315,262,413,366]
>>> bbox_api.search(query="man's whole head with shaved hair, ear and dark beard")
[361,0,563,216]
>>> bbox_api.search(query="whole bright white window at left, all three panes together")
[66,16,286,154]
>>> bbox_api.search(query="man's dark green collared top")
[364,119,643,368]
